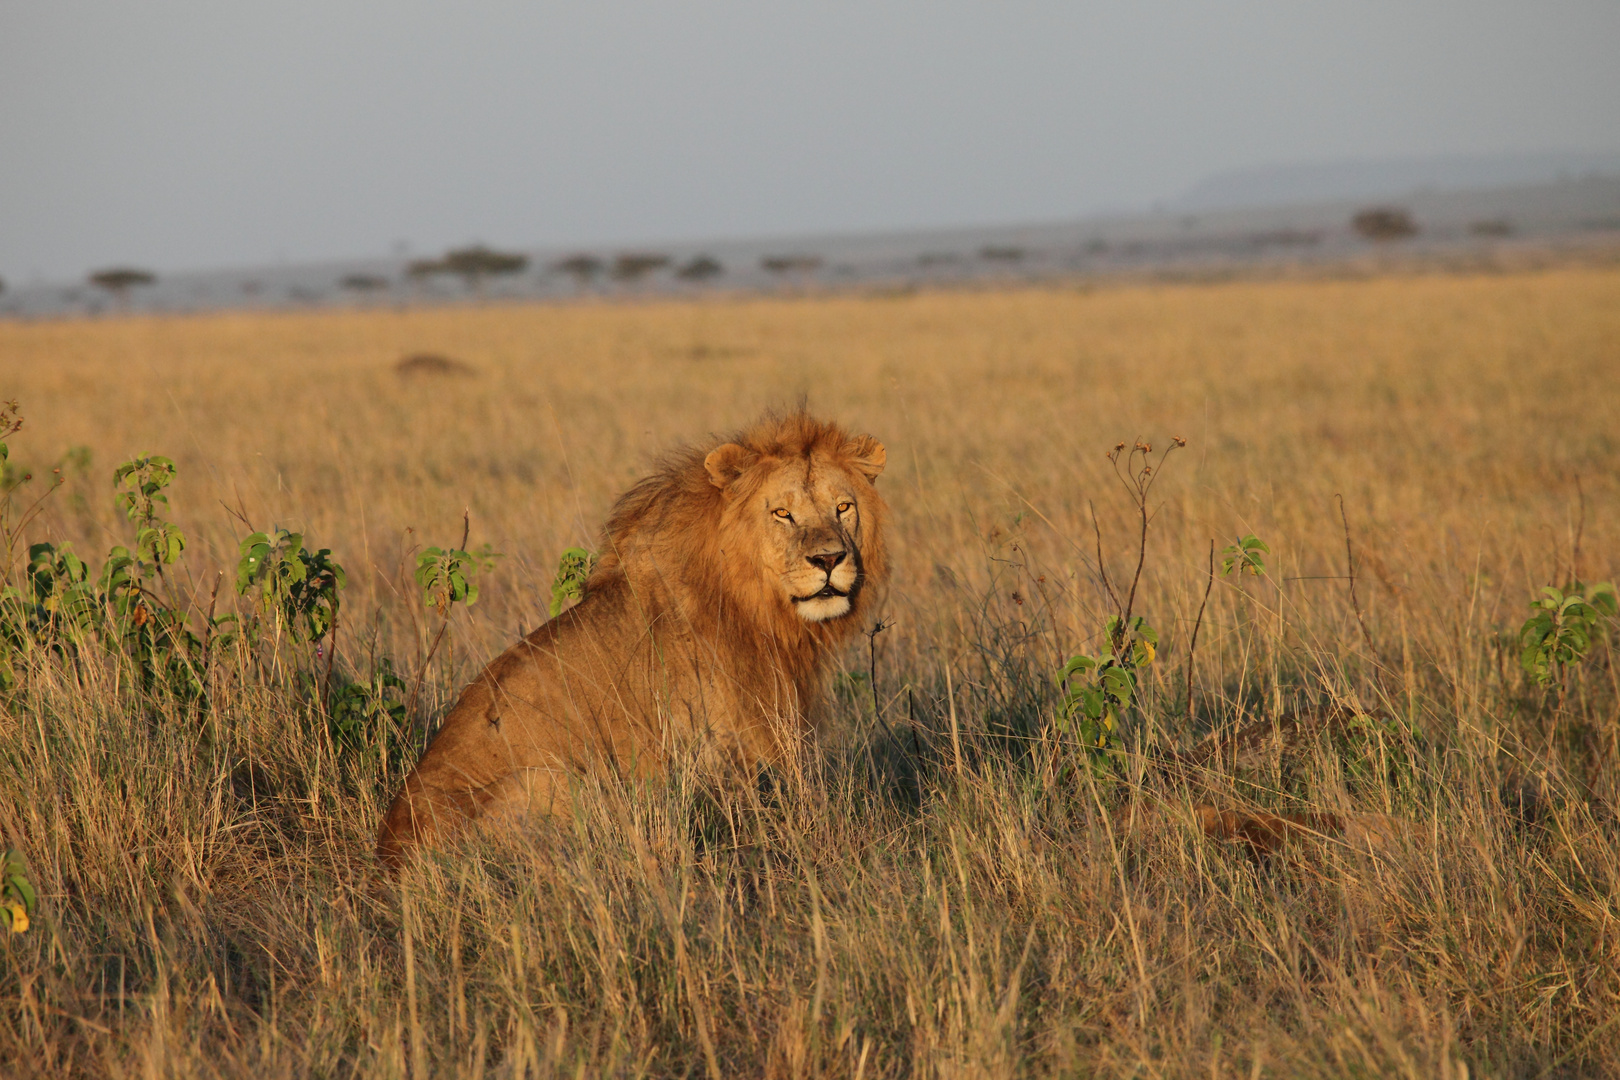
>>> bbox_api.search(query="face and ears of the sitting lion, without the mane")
[705,437,885,622]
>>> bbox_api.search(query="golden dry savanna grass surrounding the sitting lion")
[0,269,1620,1080]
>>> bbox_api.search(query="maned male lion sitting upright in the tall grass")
[377,411,886,868]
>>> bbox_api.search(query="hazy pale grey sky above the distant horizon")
[0,0,1620,282]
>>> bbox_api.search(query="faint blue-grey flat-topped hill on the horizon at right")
[1170,151,1620,210]
